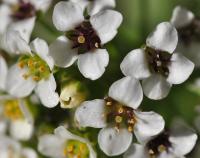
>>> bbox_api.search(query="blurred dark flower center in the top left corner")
[12,0,36,20]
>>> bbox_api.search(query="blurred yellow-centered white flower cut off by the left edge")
[0,96,34,141]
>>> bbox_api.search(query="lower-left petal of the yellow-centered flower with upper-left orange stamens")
[6,64,36,97]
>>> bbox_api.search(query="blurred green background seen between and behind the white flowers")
[29,0,200,158]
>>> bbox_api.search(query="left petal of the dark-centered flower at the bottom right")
[123,144,149,158]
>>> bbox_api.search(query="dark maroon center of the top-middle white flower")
[66,21,101,54]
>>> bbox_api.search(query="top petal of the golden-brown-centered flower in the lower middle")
[108,77,143,109]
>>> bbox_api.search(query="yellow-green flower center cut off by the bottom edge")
[63,140,90,158]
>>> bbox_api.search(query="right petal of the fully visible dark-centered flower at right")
[167,53,194,84]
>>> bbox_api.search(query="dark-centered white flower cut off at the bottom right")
[124,119,197,158]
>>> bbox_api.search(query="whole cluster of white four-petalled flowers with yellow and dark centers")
[0,0,200,158]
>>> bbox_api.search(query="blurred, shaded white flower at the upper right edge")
[171,6,200,67]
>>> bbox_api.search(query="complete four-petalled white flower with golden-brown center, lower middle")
[75,77,164,156]
